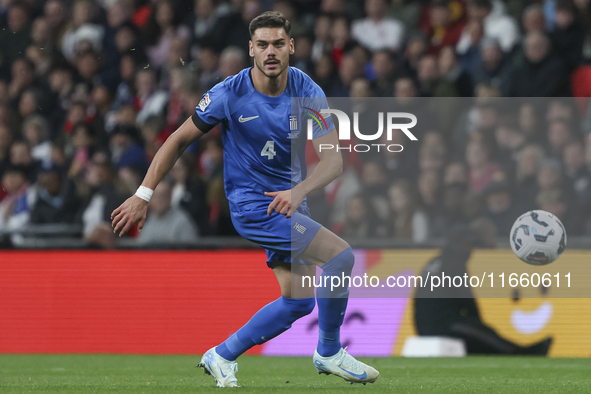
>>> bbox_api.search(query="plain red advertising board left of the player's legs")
[0,250,280,354]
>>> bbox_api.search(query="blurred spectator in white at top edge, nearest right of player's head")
[351,0,404,51]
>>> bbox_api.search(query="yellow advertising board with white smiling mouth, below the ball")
[366,250,591,357]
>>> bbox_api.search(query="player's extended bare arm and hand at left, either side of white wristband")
[111,118,204,236]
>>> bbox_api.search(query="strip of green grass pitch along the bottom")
[0,355,591,394]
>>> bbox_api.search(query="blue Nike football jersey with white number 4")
[193,67,334,210]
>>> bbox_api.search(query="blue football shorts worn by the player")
[231,199,322,265]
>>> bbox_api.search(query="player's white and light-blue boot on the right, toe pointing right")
[314,348,380,384]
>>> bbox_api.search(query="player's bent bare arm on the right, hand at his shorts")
[265,129,343,218]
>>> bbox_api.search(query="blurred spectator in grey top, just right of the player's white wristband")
[138,182,197,245]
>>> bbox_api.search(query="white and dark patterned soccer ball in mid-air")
[509,210,566,265]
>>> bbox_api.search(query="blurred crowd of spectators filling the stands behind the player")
[0,0,591,248]
